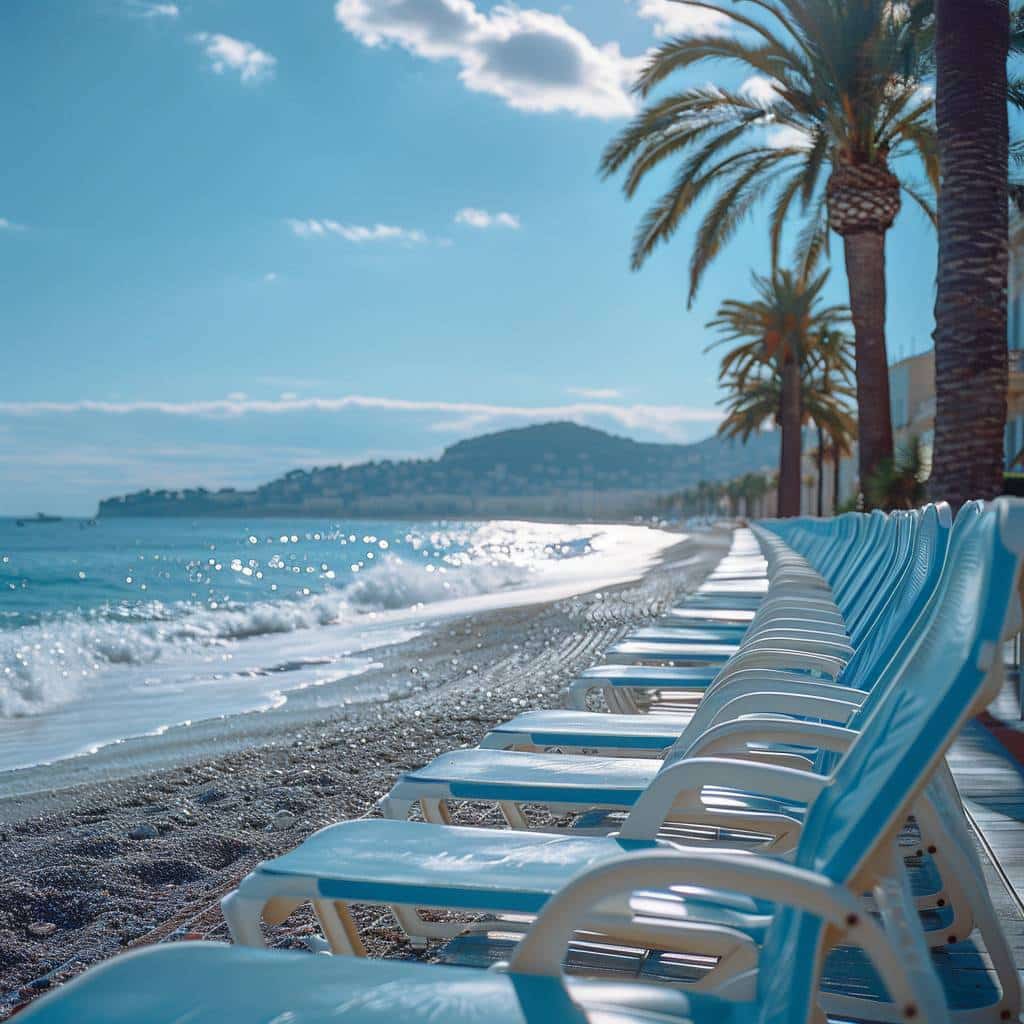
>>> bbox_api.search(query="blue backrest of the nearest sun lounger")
[758,499,1024,1024]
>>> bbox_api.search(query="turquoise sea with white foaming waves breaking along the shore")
[0,518,681,772]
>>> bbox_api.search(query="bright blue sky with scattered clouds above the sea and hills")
[0,0,935,515]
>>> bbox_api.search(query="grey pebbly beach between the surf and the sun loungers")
[0,529,730,1019]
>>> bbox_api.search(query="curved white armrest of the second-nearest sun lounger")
[618,753,828,840]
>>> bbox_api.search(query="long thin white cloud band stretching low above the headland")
[0,392,722,440]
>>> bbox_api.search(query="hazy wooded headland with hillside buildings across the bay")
[97,423,778,518]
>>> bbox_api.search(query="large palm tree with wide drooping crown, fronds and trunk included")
[601,0,938,487]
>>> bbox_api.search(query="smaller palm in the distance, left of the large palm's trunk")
[708,269,849,515]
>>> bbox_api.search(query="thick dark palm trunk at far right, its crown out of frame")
[931,0,1010,508]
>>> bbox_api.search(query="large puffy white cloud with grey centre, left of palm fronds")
[334,0,643,118]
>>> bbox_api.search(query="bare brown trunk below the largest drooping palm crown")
[843,230,893,487]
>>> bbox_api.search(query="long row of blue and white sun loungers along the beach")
[22,499,1024,1024]
